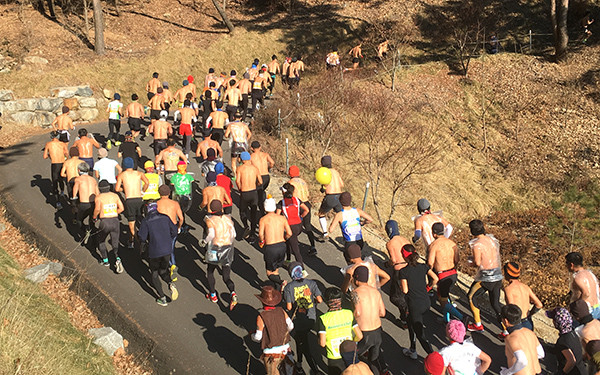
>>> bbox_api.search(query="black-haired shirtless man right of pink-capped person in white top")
[500,304,545,375]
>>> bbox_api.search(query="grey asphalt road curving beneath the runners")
[0,124,556,374]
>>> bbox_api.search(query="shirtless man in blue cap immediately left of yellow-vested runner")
[115,157,148,249]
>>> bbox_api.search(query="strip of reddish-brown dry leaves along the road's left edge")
[0,197,186,374]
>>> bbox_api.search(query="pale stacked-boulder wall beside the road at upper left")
[0,86,99,126]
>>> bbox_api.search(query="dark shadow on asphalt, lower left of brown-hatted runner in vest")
[192,313,265,374]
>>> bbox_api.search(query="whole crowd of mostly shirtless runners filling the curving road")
[39,53,600,375]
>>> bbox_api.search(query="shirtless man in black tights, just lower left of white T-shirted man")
[71,163,100,245]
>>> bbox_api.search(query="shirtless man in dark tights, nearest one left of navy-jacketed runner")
[93,180,123,273]
